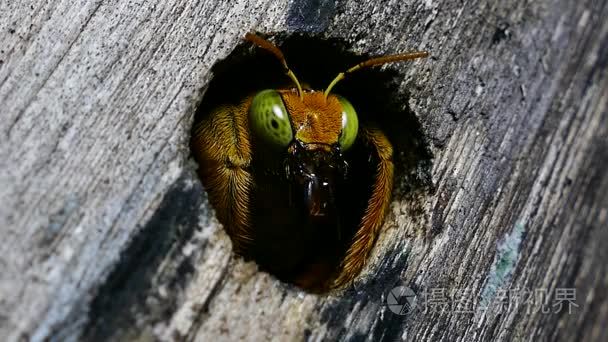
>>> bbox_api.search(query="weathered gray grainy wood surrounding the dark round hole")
[0,0,608,341]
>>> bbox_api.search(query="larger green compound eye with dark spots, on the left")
[249,89,293,147]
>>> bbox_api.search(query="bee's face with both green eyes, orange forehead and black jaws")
[249,89,358,220]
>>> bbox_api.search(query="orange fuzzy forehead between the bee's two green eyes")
[279,90,342,145]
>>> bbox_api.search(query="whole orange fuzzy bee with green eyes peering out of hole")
[191,34,428,292]
